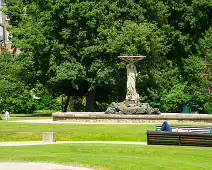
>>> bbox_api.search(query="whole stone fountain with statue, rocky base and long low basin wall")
[53,56,212,124]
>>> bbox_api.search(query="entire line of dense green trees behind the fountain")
[0,0,212,113]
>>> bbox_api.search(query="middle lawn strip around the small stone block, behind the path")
[0,121,155,142]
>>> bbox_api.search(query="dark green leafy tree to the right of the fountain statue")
[139,0,212,112]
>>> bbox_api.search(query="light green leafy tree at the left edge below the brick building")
[0,51,33,113]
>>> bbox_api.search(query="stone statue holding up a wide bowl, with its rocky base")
[105,56,160,115]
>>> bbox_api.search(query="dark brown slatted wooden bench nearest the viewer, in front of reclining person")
[147,131,212,147]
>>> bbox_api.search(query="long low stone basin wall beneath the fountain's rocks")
[53,112,212,124]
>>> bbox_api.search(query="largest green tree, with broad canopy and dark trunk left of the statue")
[5,0,170,111]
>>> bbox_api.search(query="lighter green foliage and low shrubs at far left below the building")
[0,51,60,113]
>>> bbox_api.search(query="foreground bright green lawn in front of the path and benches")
[0,144,212,170]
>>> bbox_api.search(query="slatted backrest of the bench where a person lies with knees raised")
[156,125,212,134]
